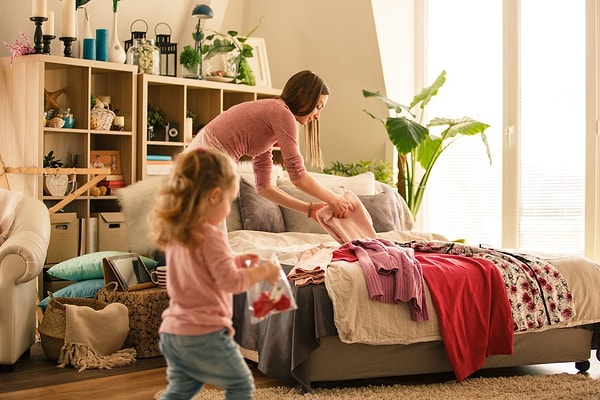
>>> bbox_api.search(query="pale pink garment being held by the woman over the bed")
[317,191,377,244]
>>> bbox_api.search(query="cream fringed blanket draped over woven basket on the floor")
[58,303,136,372]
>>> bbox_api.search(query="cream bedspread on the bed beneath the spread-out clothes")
[229,231,600,345]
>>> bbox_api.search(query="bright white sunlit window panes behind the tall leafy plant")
[418,0,585,254]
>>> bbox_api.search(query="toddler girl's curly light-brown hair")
[150,148,238,249]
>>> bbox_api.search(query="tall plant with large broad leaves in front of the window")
[363,71,492,218]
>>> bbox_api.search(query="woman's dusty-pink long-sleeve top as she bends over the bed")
[189,99,306,190]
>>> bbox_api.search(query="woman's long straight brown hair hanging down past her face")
[280,70,329,169]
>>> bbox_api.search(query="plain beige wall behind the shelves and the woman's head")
[0,0,391,170]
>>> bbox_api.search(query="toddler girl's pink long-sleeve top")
[159,223,250,335]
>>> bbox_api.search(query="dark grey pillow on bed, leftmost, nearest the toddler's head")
[239,178,286,233]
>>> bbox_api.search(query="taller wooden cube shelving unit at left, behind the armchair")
[0,55,137,256]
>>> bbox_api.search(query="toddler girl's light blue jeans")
[160,329,254,400]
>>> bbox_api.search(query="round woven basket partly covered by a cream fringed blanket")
[38,292,108,361]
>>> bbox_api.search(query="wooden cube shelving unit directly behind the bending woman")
[137,74,281,180]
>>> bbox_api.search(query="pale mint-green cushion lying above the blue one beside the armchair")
[47,251,158,281]
